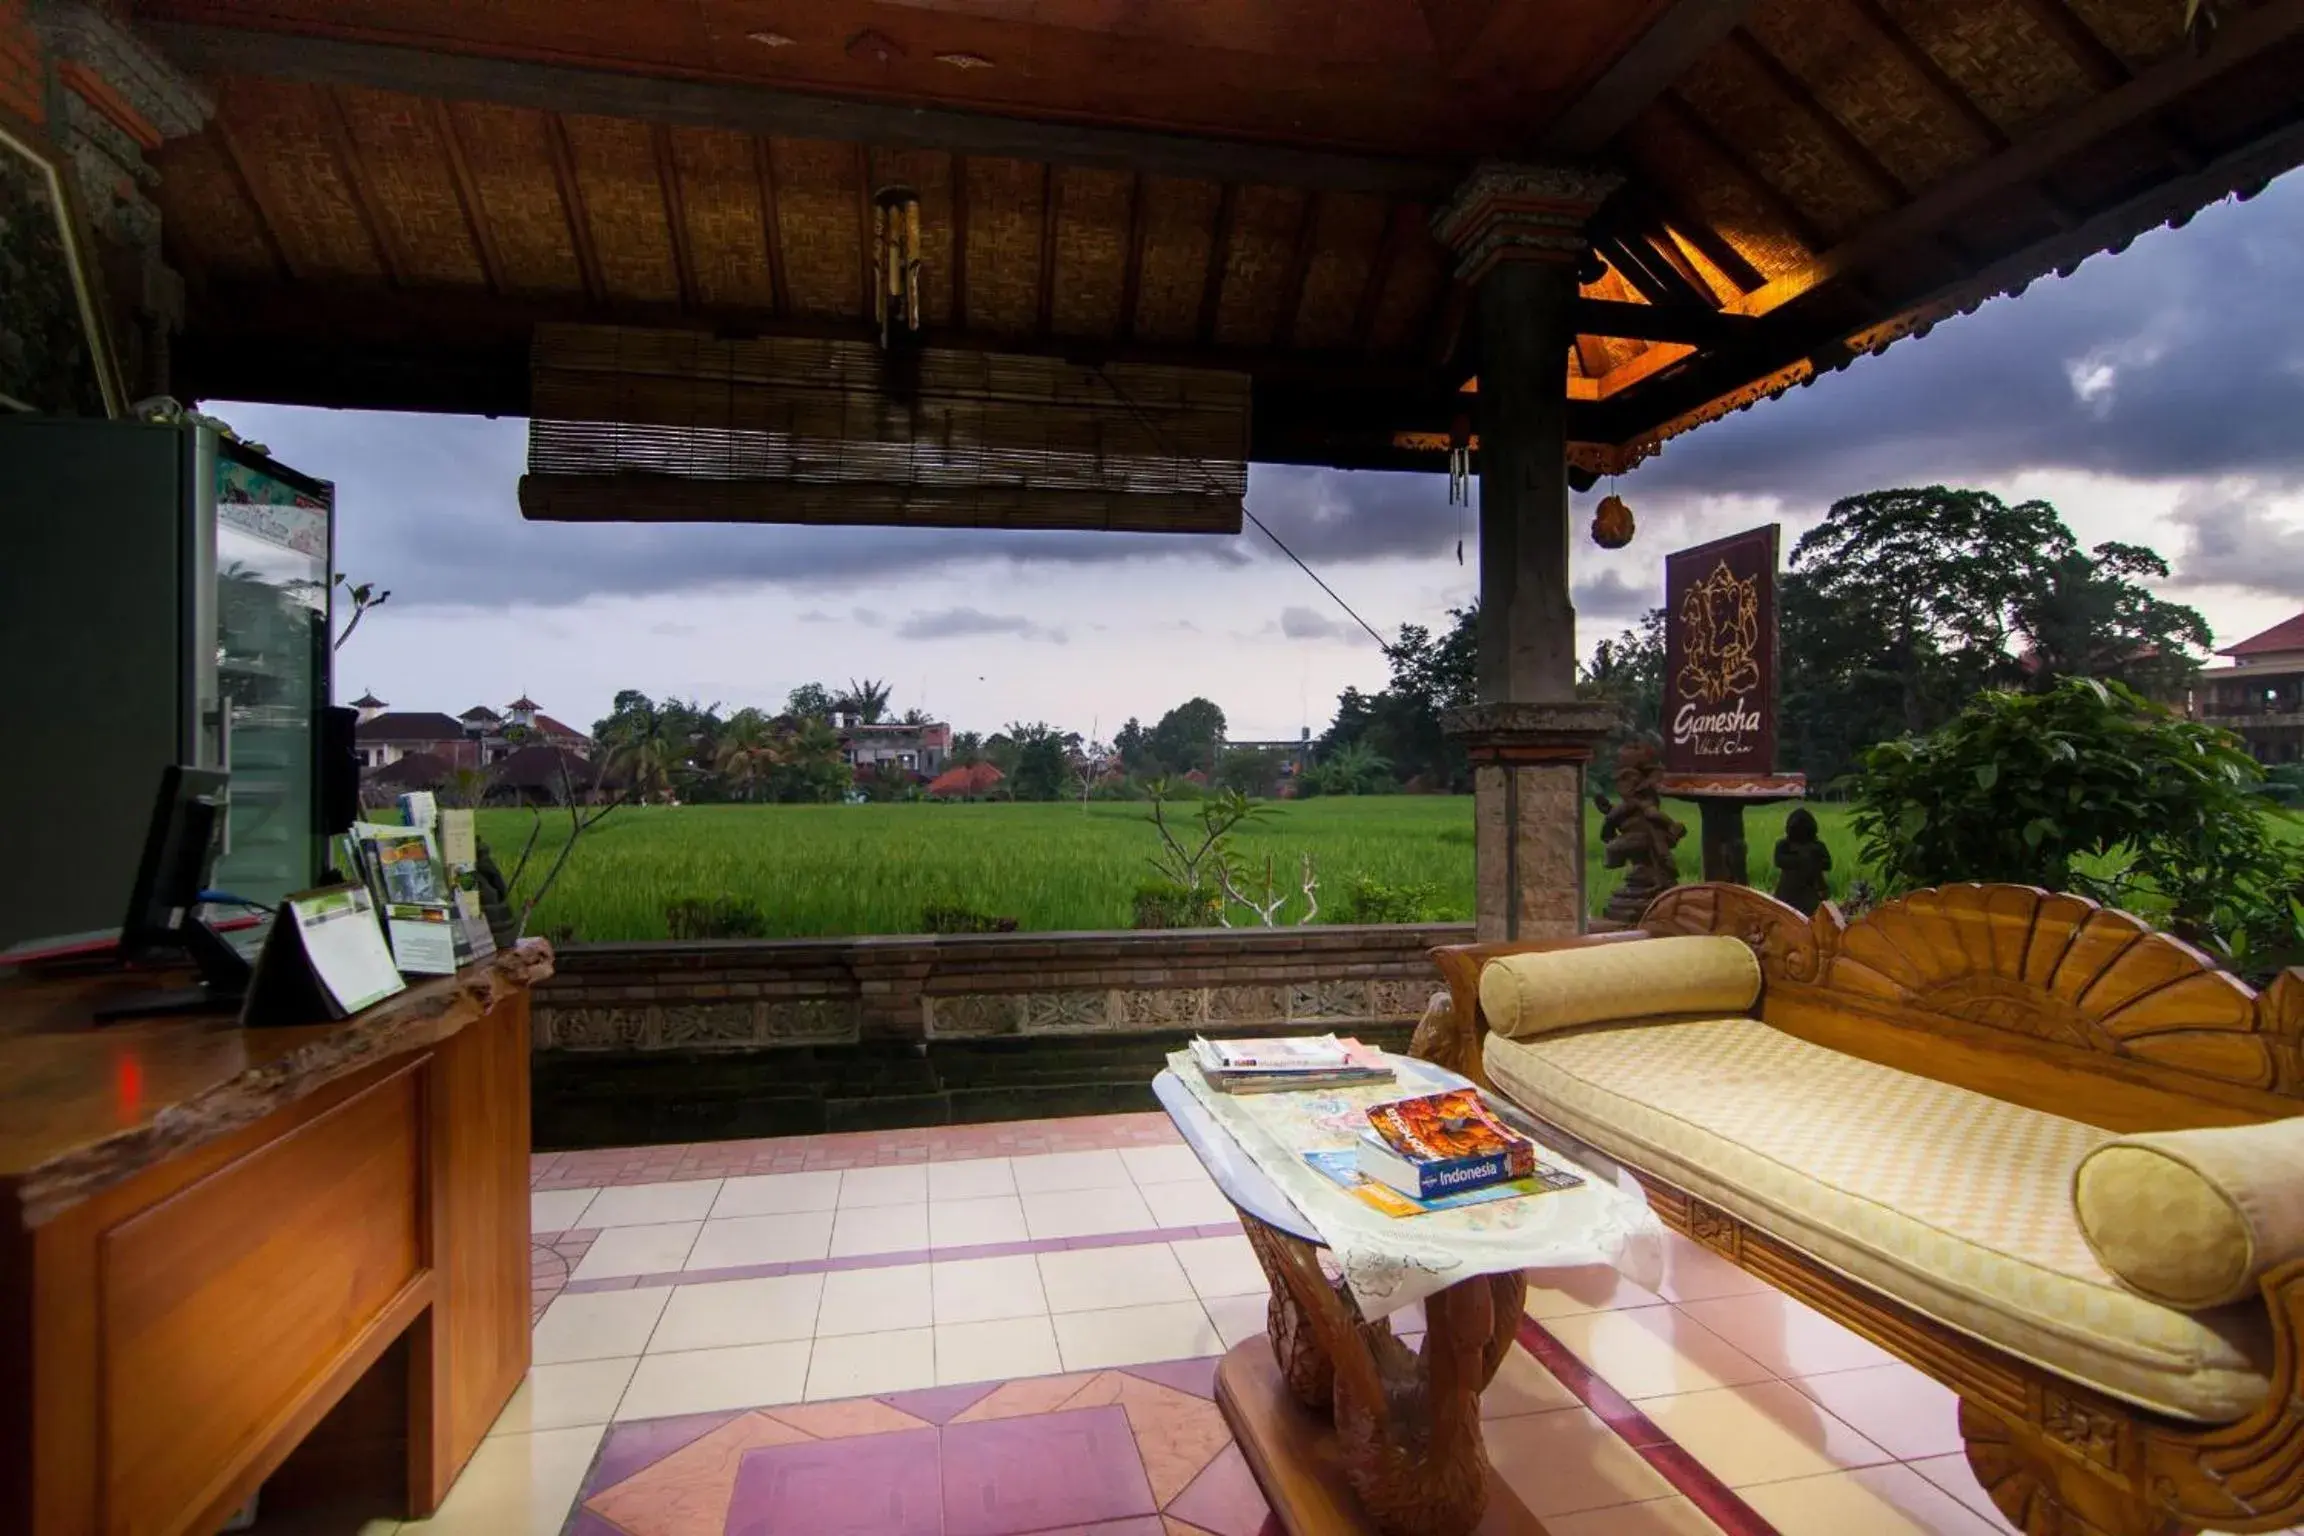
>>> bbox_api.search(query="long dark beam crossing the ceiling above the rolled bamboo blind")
[153,21,1463,198]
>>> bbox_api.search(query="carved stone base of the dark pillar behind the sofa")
[1447,700,1615,944]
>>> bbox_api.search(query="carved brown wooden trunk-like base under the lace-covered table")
[1240,1214,1528,1536]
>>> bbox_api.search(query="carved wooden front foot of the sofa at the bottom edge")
[1961,1400,2198,1536]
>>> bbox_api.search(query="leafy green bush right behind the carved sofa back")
[1852,677,2304,960]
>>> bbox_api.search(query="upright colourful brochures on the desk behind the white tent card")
[343,794,495,976]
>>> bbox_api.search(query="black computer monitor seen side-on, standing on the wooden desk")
[97,765,249,1018]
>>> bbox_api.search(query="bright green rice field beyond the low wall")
[479,794,1857,942]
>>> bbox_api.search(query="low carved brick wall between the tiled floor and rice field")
[535,923,1470,1050]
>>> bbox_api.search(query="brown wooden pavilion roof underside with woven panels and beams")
[131,0,2304,474]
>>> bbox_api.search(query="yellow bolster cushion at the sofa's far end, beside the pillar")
[1479,935,1760,1041]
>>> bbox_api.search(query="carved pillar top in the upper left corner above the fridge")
[32,0,214,401]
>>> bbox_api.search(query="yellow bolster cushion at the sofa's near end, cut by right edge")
[2071,1117,2304,1310]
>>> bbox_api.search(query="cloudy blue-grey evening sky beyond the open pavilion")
[210,173,2304,739]
